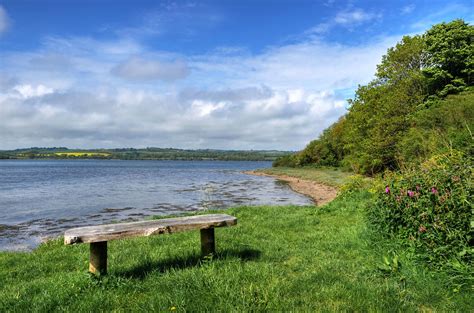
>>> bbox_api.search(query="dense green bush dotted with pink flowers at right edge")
[368,151,474,264]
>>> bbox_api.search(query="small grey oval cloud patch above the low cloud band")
[111,57,189,81]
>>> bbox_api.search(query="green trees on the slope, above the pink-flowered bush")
[275,20,474,175]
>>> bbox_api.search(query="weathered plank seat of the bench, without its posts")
[64,214,237,245]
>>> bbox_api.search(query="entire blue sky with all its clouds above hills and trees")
[0,0,474,150]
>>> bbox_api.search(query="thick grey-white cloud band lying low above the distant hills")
[0,87,344,149]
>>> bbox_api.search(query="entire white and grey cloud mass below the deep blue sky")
[0,26,398,149]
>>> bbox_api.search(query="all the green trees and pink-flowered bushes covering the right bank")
[273,20,474,302]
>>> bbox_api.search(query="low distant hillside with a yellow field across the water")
[0,147,292,161]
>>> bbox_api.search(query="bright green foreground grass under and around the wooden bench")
[0,193,474,312]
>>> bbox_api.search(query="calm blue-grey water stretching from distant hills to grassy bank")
[0,160,312,250]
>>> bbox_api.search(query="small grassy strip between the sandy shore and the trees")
[257,167,353,187]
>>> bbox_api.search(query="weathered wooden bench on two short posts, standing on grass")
[64,214,237,275]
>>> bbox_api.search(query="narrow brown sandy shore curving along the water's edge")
[244,171,337,205]
